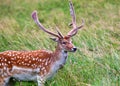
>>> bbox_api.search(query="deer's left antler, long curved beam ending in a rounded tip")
[32,11,60,38]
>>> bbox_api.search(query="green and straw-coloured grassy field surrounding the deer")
[0,0,120,86]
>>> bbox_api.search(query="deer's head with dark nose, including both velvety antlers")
[32,1,84,52]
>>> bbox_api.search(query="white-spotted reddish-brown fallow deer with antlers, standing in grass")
[0,1,84,86]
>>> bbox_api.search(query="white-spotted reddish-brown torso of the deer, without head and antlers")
[0,47,67,83]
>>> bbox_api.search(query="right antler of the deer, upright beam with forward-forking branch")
[68,1,84,37]
